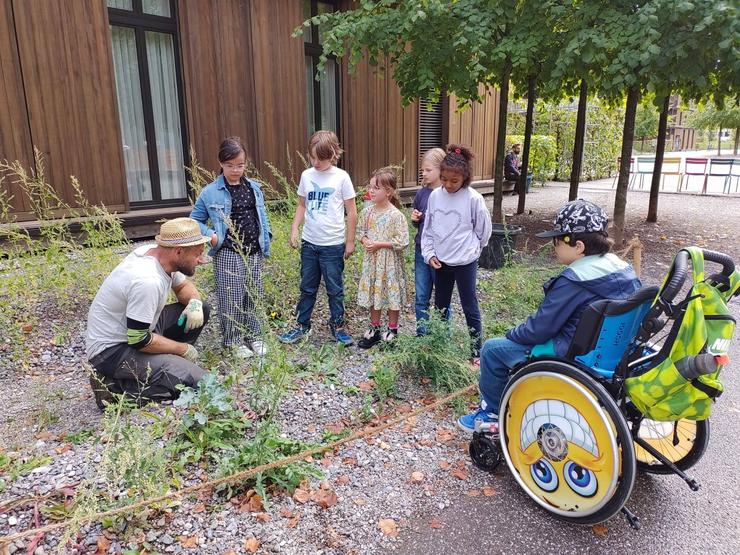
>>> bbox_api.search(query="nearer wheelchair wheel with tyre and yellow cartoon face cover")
[499,360,635,524]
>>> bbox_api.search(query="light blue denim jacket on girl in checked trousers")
[190,175,272,257]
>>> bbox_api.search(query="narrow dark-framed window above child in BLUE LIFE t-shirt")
[303,0,339,136]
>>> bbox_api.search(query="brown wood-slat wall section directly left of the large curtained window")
[8,0,127,219]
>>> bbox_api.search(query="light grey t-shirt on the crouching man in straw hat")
[85,245,186,358]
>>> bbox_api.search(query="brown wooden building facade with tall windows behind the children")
[0,0,498,226]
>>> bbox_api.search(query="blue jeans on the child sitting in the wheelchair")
[479,337,532,414]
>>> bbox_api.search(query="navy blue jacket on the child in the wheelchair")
[506,254,642,357]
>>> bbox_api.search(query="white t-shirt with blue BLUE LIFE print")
[298,166,355,246]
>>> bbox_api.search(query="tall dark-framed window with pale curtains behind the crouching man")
[108,0,187,207]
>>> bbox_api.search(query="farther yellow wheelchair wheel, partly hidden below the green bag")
[635,418,709,474]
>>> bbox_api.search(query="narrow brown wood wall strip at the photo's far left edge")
[0,0,33,213]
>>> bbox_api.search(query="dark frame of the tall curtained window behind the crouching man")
[108,0,191,209]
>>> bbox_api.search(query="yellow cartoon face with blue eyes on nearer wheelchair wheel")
[506,376,617,511]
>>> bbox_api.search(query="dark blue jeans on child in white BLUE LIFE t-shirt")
[296,241,344,329]
